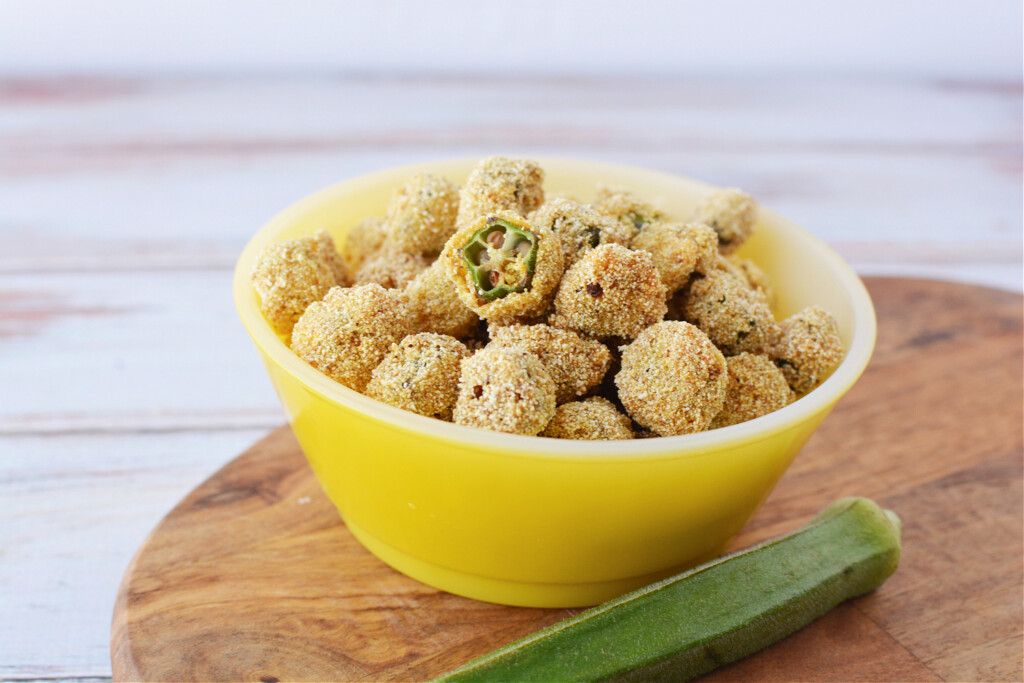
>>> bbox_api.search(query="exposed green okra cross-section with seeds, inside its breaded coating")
[462,216,538,301]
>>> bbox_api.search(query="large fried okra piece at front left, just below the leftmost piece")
[292,285,411,392]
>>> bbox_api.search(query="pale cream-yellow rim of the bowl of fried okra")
[233,157,877,461]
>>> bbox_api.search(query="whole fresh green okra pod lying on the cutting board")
[438,498,901,681]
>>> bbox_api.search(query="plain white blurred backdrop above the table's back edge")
[0,0,1022,80]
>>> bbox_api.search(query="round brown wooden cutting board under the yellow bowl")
[111,279,1024,681]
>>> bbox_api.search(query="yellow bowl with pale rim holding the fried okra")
[234,159,876,607]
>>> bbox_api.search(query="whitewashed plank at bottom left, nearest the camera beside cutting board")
[0,430,265,680]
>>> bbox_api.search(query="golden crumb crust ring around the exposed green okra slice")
[439,211,564,324]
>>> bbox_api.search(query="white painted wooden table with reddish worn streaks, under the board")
[0,76,1022,680]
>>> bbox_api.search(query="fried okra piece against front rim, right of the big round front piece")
[710,353,793,429]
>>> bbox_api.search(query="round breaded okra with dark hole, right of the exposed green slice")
[551,245,667,339]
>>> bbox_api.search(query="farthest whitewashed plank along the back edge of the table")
[0,76,1021,152]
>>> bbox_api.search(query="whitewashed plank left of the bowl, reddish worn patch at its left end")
[0,270,284,433]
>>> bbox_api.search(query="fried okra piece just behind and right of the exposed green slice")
[529,198,633,267]
